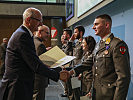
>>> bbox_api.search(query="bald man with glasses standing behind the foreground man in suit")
[33,25,50,100]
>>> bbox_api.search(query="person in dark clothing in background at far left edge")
[0,38,8,80]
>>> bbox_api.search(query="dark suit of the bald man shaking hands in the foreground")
[0,26,59,100]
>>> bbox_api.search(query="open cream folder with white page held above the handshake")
[39,46,76,68]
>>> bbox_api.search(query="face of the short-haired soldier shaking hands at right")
[92,18,106,37]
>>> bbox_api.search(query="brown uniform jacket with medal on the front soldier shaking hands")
[74,34,130,100]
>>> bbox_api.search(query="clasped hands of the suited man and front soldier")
[60,70,74,82]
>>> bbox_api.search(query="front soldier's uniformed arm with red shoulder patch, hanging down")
[113,41,130,100]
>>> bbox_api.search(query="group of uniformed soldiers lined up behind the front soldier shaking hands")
[61,25,96,100]
